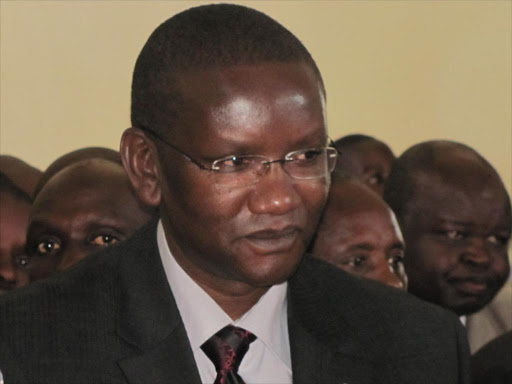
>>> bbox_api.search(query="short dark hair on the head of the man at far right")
[383,140,501,221]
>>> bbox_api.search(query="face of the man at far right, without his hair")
[402,175,511,315]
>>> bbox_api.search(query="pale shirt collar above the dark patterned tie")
[157,220,291,369]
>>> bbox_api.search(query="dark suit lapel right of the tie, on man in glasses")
[288,255,373,384]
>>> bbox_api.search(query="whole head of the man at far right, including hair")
[384,141,512,315]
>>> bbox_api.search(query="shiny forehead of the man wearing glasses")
[171,62,326,150]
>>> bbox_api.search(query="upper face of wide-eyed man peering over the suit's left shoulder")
[26,160,149,281]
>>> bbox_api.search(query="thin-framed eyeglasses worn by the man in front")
[139,127,338,187]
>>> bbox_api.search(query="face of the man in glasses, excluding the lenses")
[156,63,330,289]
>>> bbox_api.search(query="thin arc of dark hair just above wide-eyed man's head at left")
[34,147,123,196]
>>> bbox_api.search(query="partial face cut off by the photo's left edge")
[0,192,30,294]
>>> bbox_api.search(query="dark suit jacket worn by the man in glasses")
[0,223,469,384]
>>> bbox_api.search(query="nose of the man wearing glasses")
[248,162,301,215]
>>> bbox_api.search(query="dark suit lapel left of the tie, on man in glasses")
[113,223,201,384]
